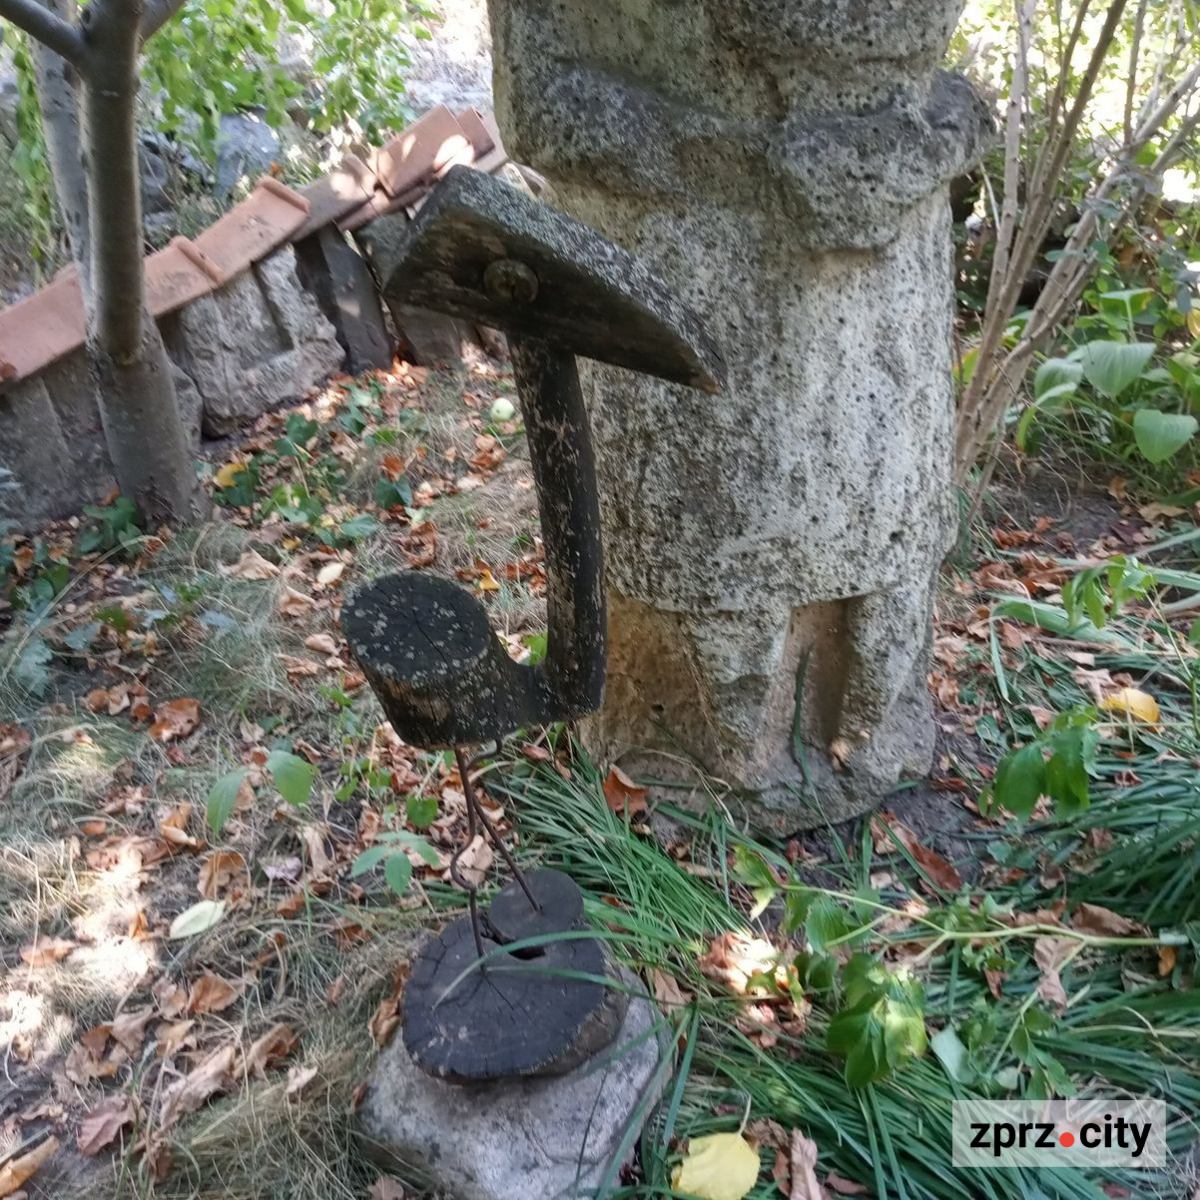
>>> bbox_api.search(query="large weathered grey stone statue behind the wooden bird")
[491,0,989,832]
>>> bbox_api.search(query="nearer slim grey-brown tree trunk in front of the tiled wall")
[82,0,205,522]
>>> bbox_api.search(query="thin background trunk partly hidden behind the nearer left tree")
[29,0,89,271]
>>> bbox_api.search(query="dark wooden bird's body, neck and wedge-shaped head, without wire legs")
[343,169,722,748]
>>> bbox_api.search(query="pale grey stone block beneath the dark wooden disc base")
[359,972,668,1200]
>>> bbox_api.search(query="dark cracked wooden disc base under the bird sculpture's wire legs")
[403,871,628,1084]
